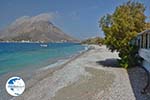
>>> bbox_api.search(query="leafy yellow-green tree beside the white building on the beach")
[100,1,146,68]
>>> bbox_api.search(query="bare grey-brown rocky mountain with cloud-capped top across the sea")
[0,15,77,42]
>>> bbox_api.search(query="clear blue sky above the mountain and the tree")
[0,0,150,39]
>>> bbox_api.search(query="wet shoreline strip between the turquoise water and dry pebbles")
[0,44,89,100]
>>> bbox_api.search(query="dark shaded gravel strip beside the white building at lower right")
[128,67,150,100]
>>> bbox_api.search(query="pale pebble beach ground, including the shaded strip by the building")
[9,45,150,100]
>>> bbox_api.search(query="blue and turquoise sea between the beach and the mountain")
[0,43,85,75]
